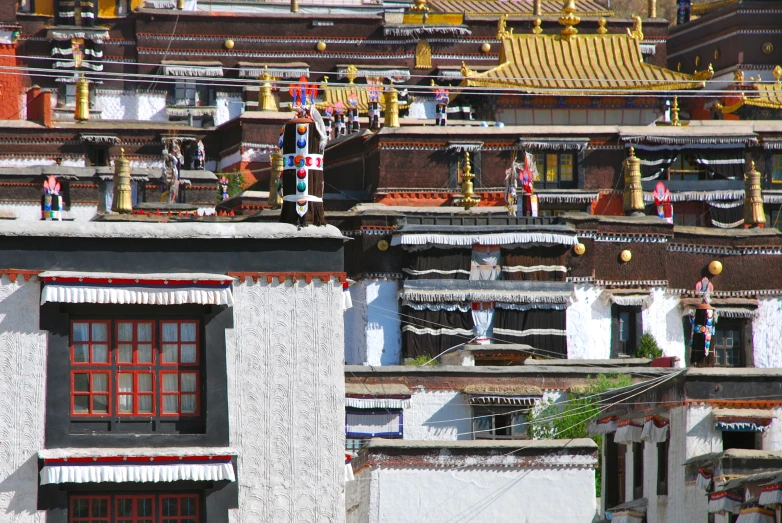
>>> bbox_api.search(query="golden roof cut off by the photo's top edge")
[427,0,614,16]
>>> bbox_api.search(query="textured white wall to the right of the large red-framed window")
[226,278,345,523]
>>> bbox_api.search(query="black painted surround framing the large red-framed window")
[41,303,233,448]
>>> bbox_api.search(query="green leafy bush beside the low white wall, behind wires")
[529,373,633,497]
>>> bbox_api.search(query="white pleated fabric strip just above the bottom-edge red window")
[41,463,236,485]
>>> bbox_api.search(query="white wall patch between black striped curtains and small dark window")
[566,285,611,360]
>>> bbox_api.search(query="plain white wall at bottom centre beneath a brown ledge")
[358,464,596,523]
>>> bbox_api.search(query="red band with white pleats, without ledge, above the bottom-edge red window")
[40,455,236,485]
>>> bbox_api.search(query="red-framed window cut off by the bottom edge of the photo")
[68,494,200,523]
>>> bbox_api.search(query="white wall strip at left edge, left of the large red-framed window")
[0,276,46,523]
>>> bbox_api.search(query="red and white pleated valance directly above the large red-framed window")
[39,271,233,305]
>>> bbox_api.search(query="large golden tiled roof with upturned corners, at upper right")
[461,34,711,95]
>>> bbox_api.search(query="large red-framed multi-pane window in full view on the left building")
[70,319,201,418]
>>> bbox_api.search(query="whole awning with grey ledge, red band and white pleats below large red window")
[38,448,236,485]
